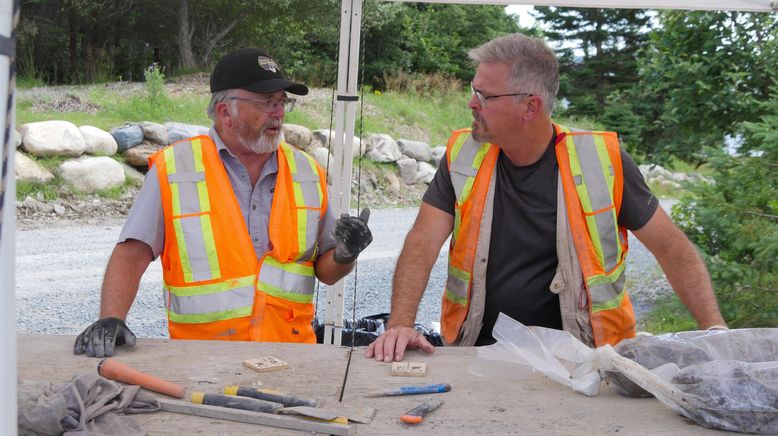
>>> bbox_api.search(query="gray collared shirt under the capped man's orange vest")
[118,127,335,259]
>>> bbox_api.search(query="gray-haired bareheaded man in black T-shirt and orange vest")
[366,34,725,362]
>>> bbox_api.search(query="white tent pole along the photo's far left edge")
[0,0,19,434]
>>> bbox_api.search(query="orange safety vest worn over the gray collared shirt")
[149,135,327,343]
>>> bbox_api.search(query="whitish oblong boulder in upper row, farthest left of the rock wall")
[19,121,86,157]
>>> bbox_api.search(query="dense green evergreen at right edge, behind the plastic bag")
[674,85,778,328]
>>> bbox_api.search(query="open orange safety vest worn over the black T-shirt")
[441,124,635,346]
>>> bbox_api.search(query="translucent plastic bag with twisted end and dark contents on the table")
[470,313,778,434]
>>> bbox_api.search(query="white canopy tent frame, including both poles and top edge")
[0,0,776,434]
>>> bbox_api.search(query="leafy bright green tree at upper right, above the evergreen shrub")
[629,11,778,164]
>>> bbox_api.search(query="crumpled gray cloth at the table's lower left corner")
[18,373,159,436]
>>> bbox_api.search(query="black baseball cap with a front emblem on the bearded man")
[211,48,308,95]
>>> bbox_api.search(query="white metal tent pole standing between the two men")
[324,0,362,345]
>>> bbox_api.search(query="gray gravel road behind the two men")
[16,201,671,338]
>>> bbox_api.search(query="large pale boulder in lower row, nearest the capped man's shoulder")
[57,156,125,194]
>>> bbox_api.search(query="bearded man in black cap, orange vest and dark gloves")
[73,48,372,357]
